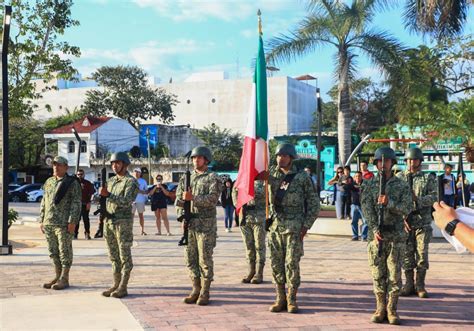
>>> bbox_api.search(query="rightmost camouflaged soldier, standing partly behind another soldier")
[398,148,437,298]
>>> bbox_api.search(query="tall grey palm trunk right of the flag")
[337,54,352,165]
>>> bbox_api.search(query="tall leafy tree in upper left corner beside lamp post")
[0,0,81,118]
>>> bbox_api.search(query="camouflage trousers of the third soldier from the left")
[184,229,216,281]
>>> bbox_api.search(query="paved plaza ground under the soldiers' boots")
[0,204,474,330]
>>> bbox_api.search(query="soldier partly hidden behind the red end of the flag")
[232,180,266,284]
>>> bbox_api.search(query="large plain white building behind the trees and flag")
[35,73,316,136]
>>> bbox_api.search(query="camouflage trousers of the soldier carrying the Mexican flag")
[268,231,303,288]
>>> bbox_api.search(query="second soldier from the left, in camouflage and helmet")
[100,152,138,298]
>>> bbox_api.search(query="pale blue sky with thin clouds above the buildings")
[64,0,472,98]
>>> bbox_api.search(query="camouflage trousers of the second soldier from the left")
[104,219,133,273]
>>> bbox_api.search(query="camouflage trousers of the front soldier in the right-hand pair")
[367,240,405,294]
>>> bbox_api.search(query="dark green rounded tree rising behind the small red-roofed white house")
[84,66,178,129]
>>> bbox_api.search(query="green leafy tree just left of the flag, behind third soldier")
[195,123,243,170]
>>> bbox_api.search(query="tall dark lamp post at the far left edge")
[0,6,13,255]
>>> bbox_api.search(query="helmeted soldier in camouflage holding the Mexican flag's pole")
[268,144,320,313]
